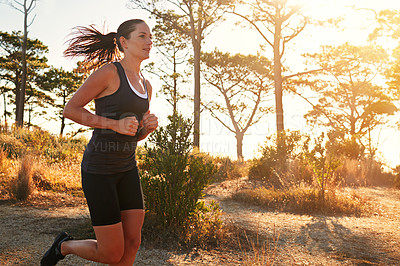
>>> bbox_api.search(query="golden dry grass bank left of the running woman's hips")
[0,129,85,200]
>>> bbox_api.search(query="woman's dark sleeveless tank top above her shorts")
[81,62,149,174]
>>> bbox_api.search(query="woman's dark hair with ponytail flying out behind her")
[64,19,144,70]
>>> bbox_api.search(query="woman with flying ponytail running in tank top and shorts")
[41,19,158,266]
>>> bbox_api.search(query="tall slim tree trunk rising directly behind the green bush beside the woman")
[193,40,201,148]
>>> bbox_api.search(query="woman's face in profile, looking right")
[120,23,153,60]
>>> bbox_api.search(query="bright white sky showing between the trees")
[0,0,400,166]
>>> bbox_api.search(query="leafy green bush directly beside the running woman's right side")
[140,115,216,228]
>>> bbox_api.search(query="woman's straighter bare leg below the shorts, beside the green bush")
[113,209,144,266]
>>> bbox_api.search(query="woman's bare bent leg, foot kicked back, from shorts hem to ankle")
[61,222,124,265]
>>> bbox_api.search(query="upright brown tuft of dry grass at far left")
[9,156,34,201]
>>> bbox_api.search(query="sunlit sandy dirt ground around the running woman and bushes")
[0,179,400,266]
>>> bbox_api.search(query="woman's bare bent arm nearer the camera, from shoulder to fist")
[63,64,138,136]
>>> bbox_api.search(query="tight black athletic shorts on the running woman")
[82,167,144,226]
